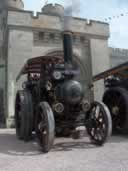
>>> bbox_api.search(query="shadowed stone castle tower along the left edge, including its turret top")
[0,0,24,125]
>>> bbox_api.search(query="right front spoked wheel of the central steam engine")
[86,102,112,145]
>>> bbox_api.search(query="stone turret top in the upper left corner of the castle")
[0,0,24,10]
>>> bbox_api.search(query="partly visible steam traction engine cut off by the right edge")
[93,62,128,133]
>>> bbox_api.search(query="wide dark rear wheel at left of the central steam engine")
[15,90,33,141]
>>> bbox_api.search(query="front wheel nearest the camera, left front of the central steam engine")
[36,102,55,153]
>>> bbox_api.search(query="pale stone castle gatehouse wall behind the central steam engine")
[0,4,128,126]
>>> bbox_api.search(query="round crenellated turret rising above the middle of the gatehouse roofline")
[42,4,64,17]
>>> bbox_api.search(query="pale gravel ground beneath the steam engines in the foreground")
[0,130,128,171]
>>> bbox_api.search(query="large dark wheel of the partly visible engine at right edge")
[103,87,128,133]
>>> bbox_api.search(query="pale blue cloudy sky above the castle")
[23,0,128,49]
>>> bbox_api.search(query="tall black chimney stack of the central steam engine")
[63,31,73,65]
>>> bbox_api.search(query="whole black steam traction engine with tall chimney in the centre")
[15,32,111,152]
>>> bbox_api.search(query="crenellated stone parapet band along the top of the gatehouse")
[7,10,109,39]
